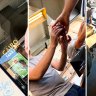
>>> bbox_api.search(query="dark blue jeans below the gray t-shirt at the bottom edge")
[65,85,85,96]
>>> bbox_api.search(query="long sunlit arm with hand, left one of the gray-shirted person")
[29,27,62,80]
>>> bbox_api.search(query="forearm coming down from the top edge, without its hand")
[61,0,79,17]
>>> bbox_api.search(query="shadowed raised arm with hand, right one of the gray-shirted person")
[51,33,69,71]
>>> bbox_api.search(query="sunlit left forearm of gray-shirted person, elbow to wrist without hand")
[29,45,55,80]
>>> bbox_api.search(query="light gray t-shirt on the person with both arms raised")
[29,54,72,96]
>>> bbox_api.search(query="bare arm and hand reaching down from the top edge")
[53,0,79,33]
